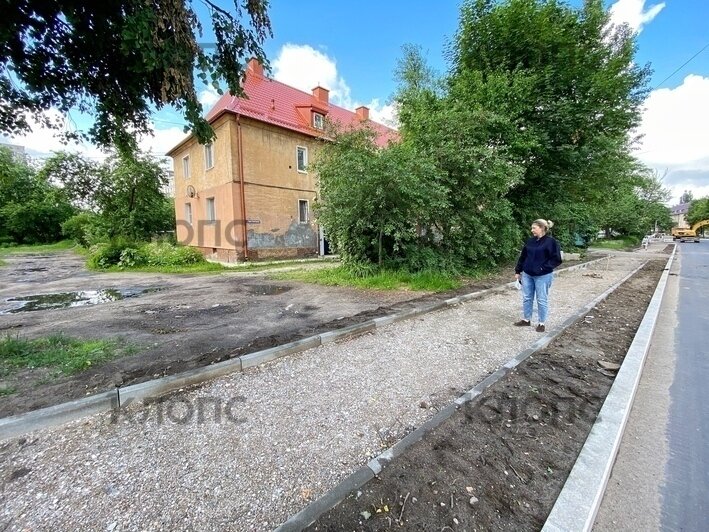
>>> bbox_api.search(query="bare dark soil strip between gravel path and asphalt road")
[309,260,666,531]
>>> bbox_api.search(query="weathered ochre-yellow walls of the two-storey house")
[172,114,322,260]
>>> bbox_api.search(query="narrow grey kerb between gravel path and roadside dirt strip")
[275,257,652,532]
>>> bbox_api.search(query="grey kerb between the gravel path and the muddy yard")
[0,255,610,439]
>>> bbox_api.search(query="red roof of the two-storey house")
[202,72,398,147]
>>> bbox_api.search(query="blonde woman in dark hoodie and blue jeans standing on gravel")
[515,219,561,332]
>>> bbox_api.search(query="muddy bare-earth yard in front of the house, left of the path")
[0,252,556,417]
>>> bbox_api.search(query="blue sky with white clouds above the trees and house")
[2,0,709,204]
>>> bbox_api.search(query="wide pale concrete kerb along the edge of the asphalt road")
[542,246,677,532]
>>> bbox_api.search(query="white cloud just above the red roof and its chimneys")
[271,43,396,127]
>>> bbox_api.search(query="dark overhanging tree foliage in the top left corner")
[0,0,271,150]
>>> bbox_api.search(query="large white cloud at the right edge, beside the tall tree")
[637,74,709,203]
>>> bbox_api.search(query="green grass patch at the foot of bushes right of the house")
[271,266,462,292]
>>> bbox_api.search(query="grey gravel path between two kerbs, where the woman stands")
[0,253,649,531]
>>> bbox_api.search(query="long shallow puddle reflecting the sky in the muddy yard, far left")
[0,288,161,314]
